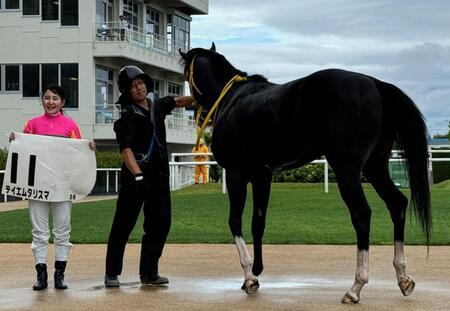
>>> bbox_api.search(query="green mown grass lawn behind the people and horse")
[0,183,450,245]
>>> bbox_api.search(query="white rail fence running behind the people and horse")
[0,150,450,202]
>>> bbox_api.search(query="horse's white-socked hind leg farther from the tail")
[333,166,372,303]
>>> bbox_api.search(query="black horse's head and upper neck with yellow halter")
[179,42,247,126]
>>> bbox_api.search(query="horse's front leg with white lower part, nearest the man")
[226,169,259,294]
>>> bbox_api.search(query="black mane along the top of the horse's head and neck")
[180,48,267,82]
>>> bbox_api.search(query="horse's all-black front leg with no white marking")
[251,167,272,276]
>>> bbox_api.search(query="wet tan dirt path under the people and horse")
[0,244,450,311]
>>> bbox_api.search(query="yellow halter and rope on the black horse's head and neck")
[189,55,247,147]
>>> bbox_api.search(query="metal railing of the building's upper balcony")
[94,22,189,57]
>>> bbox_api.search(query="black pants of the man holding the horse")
[106,168,171,276]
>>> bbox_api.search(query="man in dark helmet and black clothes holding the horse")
[105,66,192,287]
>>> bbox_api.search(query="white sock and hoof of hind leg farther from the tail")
[342,249,369,303]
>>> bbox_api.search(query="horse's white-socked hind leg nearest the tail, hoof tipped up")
[363,160,415,296]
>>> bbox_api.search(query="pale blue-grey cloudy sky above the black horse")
[191,0,450,134]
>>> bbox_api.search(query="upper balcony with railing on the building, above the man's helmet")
[93,22,189,73]
